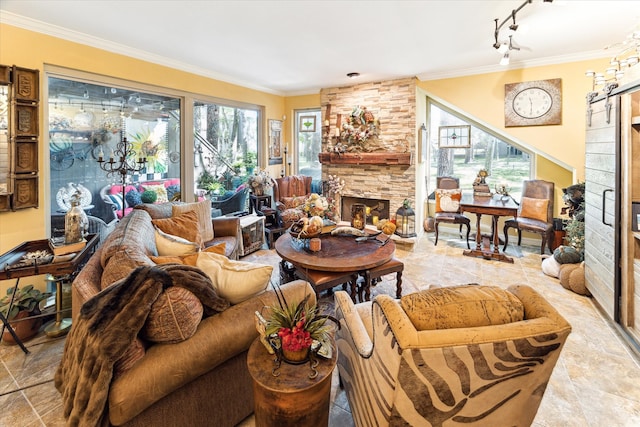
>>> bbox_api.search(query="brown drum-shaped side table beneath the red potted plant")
[247,339,337,427]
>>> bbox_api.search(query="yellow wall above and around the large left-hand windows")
[0,24,284,293]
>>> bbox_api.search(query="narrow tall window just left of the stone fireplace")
[295,110,322,181]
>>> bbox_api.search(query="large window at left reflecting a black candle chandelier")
[48,76,181,228]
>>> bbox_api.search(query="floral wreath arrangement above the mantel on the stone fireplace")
[328,105,380,153]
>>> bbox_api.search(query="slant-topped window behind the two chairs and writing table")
[427,102,532,199]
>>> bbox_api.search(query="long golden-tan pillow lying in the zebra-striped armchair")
[400,285,524,331]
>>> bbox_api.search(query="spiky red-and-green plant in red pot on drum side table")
[265,291,331,364]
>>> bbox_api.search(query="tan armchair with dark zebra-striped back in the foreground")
[335,285,571,427]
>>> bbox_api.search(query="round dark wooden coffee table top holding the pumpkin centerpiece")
[275,233,396,272]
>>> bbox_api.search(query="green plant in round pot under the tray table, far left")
[0,285,51,344]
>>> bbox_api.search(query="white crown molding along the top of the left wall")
[0,10,284,96]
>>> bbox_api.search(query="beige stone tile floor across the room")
[0,231,640,427]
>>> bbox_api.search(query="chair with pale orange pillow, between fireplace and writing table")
[435,176,471,249]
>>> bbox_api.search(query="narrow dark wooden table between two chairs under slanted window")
[460,194,518,263]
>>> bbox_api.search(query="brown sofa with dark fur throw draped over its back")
[65,204,315,426]
